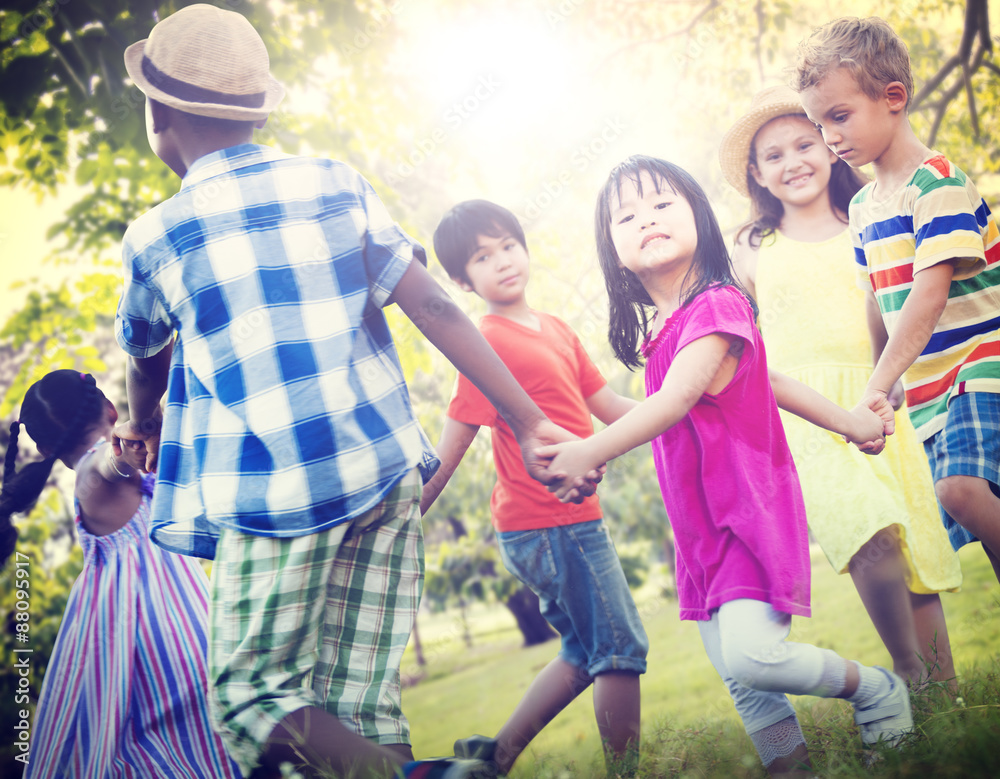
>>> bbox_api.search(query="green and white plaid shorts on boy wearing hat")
[209,469,424,775]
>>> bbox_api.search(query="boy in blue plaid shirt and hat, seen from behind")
[115,5,590,777]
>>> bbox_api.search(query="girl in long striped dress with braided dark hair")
[0,370,240,779]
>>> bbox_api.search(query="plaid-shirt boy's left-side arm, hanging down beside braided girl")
[111,342,174,473]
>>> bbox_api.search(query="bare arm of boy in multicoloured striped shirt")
[861,262,955,408]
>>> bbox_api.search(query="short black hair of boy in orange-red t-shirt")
[434,200,528,284]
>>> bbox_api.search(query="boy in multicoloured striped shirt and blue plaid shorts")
[794,17,1000,578]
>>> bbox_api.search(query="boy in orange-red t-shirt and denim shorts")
[420,200,649,774]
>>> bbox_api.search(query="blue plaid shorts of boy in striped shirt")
[924,392,1000,550]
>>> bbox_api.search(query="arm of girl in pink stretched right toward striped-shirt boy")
[767,368,894,454]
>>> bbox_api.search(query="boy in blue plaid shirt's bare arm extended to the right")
[391,262,595,500]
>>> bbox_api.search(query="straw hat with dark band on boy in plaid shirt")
[125,3,285,121]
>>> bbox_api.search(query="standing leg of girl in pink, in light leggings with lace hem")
[698,611,812,779]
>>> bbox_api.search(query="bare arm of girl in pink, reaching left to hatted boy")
[538,333,743,502]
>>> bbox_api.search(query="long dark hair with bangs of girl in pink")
[594,155,757,370]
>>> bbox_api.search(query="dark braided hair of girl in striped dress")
[0,370,105,566]
